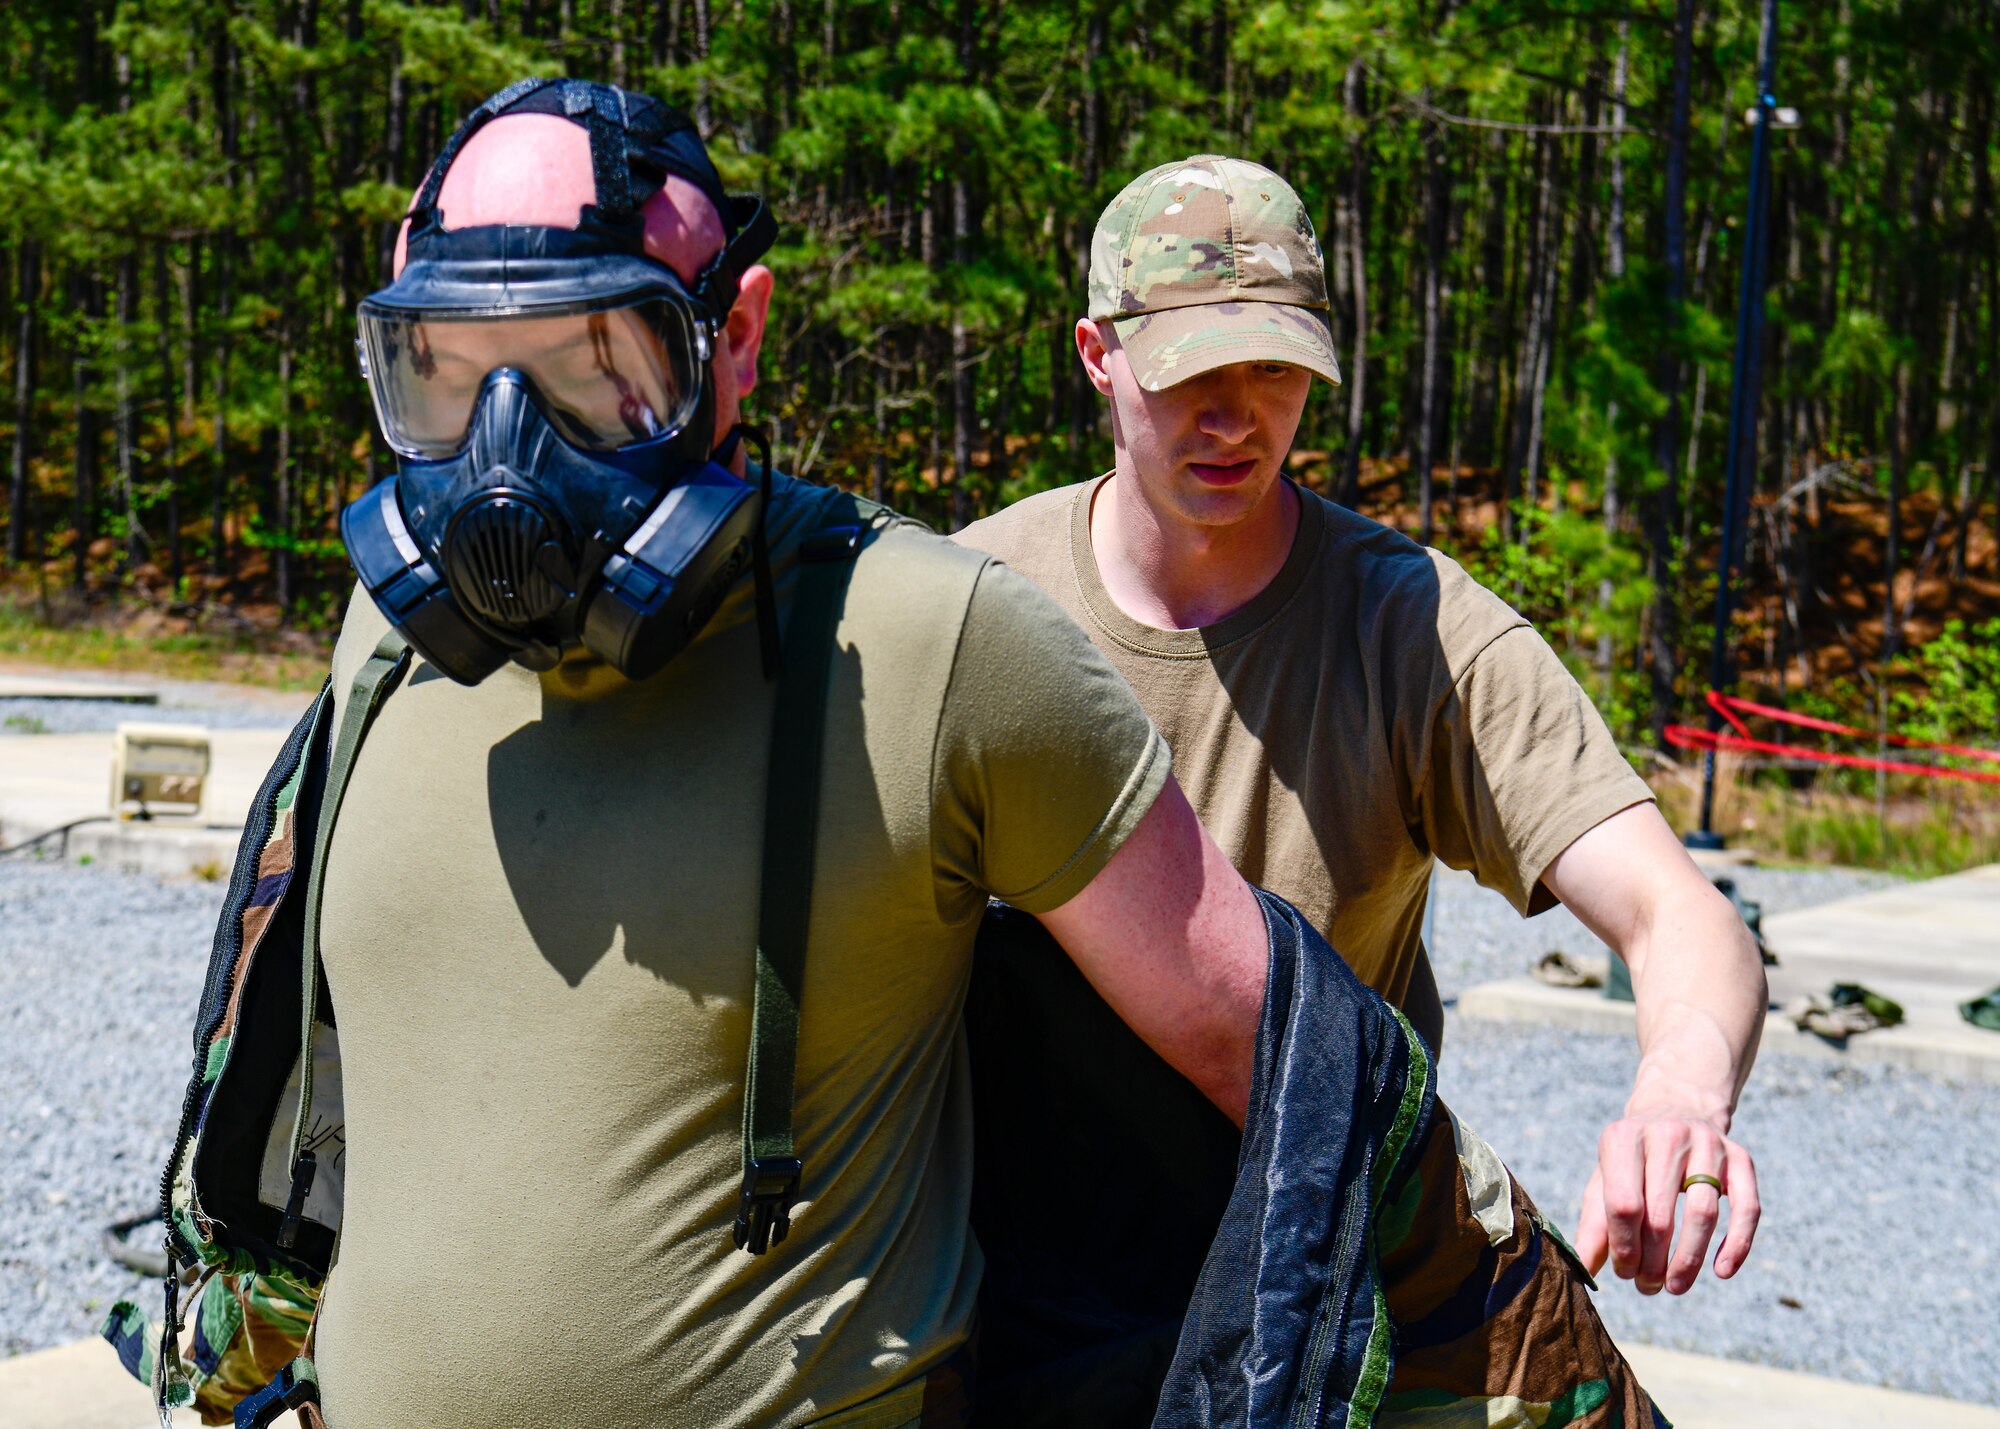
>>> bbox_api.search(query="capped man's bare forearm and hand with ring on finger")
[1542,805,1766,1295]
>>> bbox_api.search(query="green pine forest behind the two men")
[0,0,2000,764]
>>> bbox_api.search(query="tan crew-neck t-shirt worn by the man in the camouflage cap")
[956,476,1652,1003]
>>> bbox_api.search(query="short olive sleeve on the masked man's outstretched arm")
[932,562,1170,921]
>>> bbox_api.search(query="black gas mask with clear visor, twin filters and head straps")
[340,80,776,684]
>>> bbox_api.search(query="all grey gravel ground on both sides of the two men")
[0,844,2000,1405]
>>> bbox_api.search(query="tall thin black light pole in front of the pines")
[1684,0,1798,849]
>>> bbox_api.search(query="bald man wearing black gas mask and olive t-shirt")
[304,80,1266,1429]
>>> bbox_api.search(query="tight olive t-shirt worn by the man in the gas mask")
[316,480,1168,1429]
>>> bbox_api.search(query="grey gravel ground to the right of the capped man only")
[1434,869,2000,1411]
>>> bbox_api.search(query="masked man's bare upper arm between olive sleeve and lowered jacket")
[1042,779,1270,1127]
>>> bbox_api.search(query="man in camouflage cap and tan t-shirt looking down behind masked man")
[958,154,1764,1423]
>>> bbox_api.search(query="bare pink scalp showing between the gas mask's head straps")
[396,114,728,284]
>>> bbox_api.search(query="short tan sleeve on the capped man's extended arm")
[1422,624,1652,917]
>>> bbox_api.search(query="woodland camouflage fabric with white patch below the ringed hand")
[1376,1103,1668,1429]
